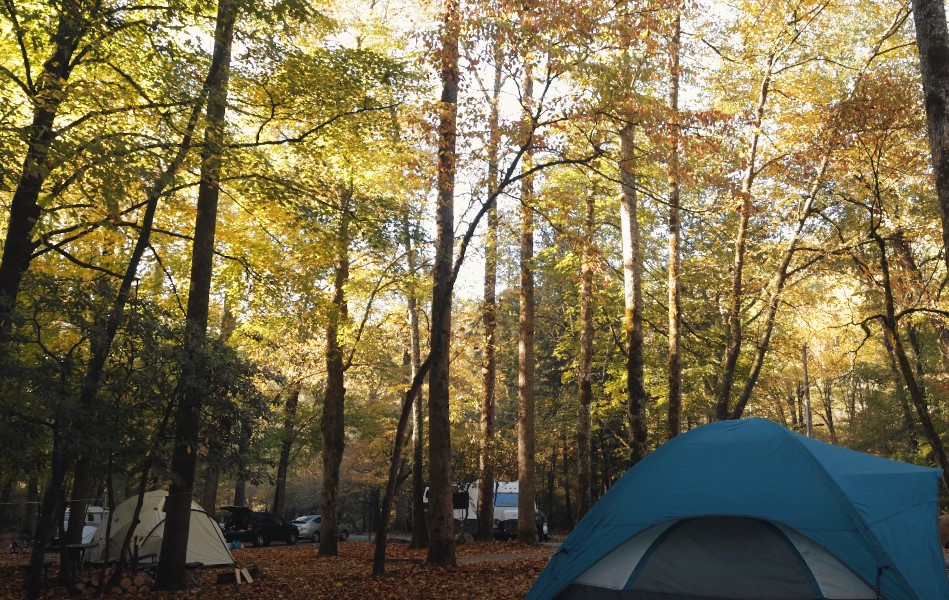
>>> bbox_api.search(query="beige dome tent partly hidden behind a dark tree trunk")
[88,490,234,567]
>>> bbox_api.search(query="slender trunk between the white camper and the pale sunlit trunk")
[577,186,596,519]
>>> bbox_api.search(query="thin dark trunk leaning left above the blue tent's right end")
[864,226,949,489]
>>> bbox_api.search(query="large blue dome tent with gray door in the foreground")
[527,419,949,600]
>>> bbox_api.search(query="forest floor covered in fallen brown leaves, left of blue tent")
[0,540,557,600]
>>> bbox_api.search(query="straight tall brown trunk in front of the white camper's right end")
[517,58,537,544]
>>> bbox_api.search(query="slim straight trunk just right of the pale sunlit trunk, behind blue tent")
[666,2,682,439]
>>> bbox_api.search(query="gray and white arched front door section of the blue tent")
[557,517,877,600]
